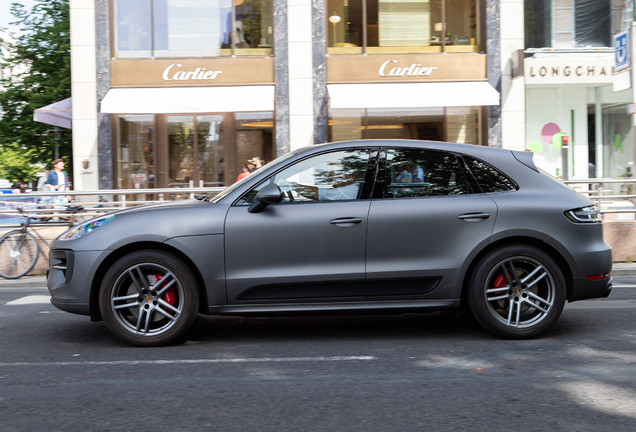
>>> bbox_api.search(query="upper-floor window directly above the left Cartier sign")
[113,0,272,58]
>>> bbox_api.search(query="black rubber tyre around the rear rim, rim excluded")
[468,245,566,339]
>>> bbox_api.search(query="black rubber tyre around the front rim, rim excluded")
[99,250,199,346]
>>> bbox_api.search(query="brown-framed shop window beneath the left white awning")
[113,112,276,189]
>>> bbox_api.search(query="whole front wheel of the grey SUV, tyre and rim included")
[99,250,199,346]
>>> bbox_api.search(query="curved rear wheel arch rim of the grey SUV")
[460,236,574,312]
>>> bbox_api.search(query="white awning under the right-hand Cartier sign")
[327,82,499,108]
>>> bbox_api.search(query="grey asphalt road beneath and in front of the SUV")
[0,277,636,432]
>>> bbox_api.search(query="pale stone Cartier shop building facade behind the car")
[71,0,526,190]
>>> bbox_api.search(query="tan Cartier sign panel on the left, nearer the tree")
[110,57,274,88]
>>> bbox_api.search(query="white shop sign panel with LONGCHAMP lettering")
[524,57,614,85]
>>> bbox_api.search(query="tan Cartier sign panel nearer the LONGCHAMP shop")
[327,53,486,84]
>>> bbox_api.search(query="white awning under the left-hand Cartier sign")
[101,86,274,114]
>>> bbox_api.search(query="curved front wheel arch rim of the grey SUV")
[89,241,208,321]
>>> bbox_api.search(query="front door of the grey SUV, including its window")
[225,149,377,304]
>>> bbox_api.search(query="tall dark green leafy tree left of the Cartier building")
[0,0,72,172]
